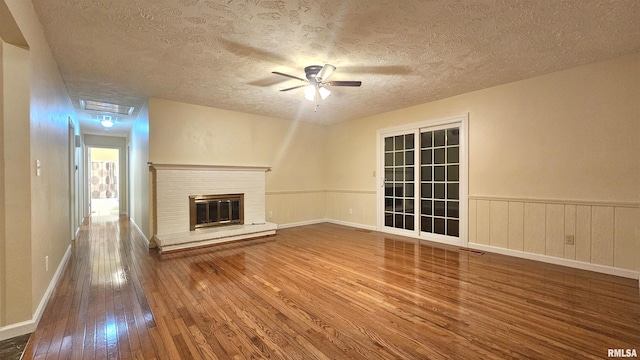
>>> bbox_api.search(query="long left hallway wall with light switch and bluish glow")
[24,0,79,324]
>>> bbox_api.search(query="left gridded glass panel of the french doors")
[384,134,416,230]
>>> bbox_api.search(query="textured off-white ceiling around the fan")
[33,0,640,133]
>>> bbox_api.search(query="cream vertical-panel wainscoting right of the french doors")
[469,196,640,278]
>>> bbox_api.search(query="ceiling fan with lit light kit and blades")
[272,64,362,111]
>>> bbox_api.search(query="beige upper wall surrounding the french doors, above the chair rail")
[327,55,640,202]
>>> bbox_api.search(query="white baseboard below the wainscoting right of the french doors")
[467,243,640,280]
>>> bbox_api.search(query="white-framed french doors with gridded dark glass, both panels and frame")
[378,115,467,245]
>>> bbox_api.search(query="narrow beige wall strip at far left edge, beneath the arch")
[0,39,32,324]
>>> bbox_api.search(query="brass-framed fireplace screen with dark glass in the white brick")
[189,194,244,230]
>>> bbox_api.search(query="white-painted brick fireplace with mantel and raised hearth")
[150,164,277,252]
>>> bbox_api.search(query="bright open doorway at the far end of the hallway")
[89,147,120,216]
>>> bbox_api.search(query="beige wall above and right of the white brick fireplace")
[149,95,325,223]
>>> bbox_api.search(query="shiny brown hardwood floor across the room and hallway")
[24,217,640,359]
